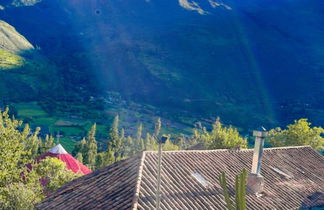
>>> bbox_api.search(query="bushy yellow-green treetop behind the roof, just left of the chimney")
[193,118,247,149]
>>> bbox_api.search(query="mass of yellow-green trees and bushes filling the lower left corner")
[0,109,78,210]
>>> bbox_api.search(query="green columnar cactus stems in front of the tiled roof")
[219,169,247,210]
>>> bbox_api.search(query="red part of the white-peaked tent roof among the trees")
[36,152,91,175]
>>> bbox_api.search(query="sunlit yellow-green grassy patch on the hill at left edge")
[0,49,25,71]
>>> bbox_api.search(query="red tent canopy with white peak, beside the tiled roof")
[36,144,91,174]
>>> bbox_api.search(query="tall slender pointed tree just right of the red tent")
[86,124,98,168]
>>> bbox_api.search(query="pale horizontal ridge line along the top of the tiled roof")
[144,145,311,153]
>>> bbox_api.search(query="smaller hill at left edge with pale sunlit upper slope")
[0,21,57,105]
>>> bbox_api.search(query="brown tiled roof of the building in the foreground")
[37,147,324,209]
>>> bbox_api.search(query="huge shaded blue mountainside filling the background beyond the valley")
[2,0,324,128]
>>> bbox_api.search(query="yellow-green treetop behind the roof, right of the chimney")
[267,118,324,150]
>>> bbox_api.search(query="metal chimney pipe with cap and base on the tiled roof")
[247,127,268,194]
